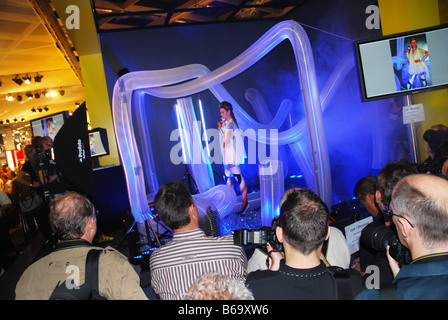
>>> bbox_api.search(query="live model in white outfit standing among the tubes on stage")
[218,101,248,213]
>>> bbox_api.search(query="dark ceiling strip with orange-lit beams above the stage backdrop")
[91,0,307,32]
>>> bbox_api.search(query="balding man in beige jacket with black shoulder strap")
[15,192,148,300]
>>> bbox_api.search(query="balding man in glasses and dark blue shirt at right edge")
[357,174,448,300]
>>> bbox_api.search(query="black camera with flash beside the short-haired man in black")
[233,217,283,251]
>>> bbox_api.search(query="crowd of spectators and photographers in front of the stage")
[5,125,448,300]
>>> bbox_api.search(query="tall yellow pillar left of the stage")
[52,0,120,166]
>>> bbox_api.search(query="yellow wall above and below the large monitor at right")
[378,0,448,162]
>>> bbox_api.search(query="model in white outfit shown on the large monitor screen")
[404,38,430,89]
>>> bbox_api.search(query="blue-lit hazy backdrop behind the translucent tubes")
[101,0,406,210]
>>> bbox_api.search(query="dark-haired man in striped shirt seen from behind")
[150,181,247,300]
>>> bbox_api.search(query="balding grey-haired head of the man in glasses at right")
[392,174,448,247]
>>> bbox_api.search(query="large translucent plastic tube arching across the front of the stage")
[112,21,331,222]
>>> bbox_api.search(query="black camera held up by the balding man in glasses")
[360,221,412,265]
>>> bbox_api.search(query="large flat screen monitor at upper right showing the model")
[355,24,448,101]
